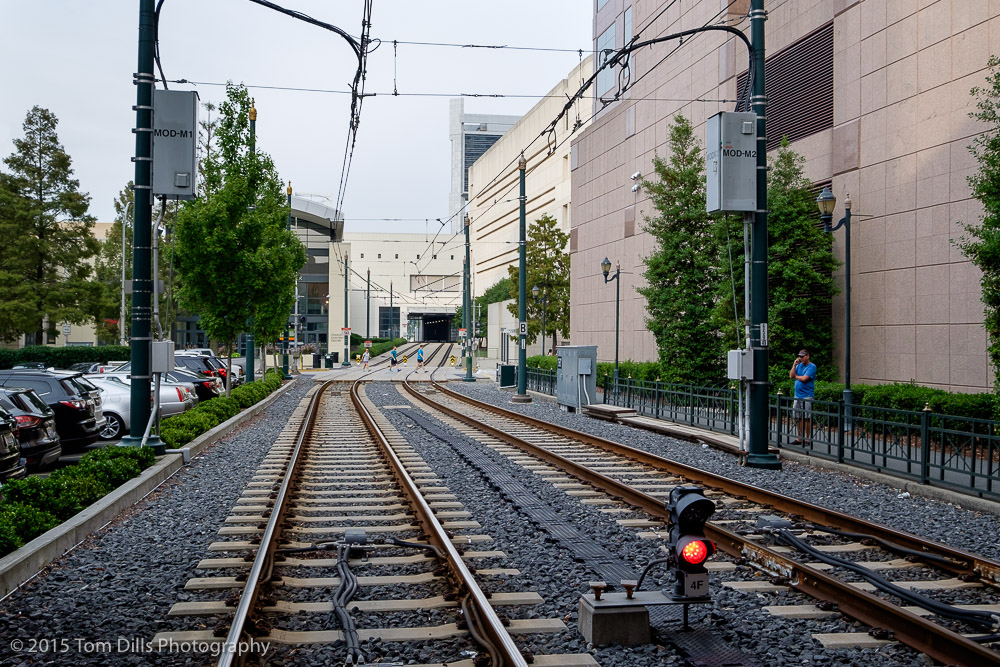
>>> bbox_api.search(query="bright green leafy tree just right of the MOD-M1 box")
[174,83,306,391]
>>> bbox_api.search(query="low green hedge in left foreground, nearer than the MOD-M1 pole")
[0,447,156,556]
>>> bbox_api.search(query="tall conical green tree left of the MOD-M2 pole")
[638,116,728,384]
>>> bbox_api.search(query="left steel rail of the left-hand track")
[216,380,333,667]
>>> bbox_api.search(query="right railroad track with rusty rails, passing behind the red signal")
[396,375,1000,665]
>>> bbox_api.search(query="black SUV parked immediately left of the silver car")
[0,370,106,450]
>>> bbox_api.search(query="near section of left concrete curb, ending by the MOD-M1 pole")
[0,456,181,599]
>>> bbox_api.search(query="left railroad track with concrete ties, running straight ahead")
[151,378,596,667]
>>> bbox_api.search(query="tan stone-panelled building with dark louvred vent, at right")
[571,0,1000,391]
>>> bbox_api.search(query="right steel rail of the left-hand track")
[351,380,528,667]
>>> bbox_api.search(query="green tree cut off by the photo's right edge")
[957,56,1000,391]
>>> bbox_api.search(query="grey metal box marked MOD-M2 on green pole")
[705,111,757,213]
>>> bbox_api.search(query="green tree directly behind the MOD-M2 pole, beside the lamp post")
[715,138,839,382]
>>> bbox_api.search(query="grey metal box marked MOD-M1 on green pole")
[153,90,198,199]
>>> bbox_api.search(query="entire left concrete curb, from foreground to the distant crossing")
[0,382,294,599]
